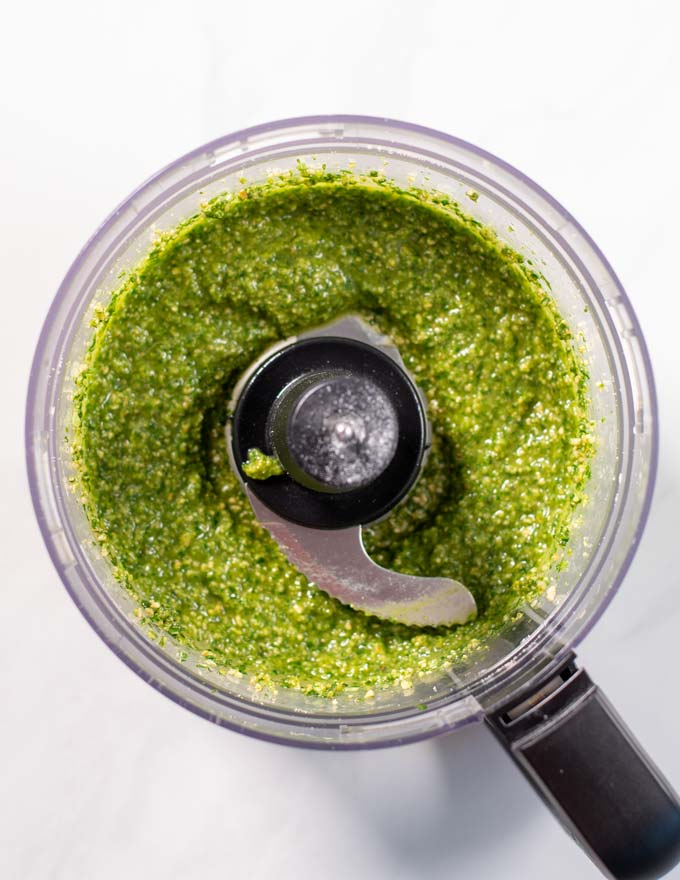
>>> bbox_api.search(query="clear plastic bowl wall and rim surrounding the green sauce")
[26,116,657,748]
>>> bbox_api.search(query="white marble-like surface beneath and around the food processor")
[0,0,680,880]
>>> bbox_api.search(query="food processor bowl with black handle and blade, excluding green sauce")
[26,116,680,878]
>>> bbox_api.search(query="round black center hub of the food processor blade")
[232,336,427,529]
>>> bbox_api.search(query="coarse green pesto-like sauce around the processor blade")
[74,169,592,697]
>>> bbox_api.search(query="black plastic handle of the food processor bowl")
[487,657,680,880]
